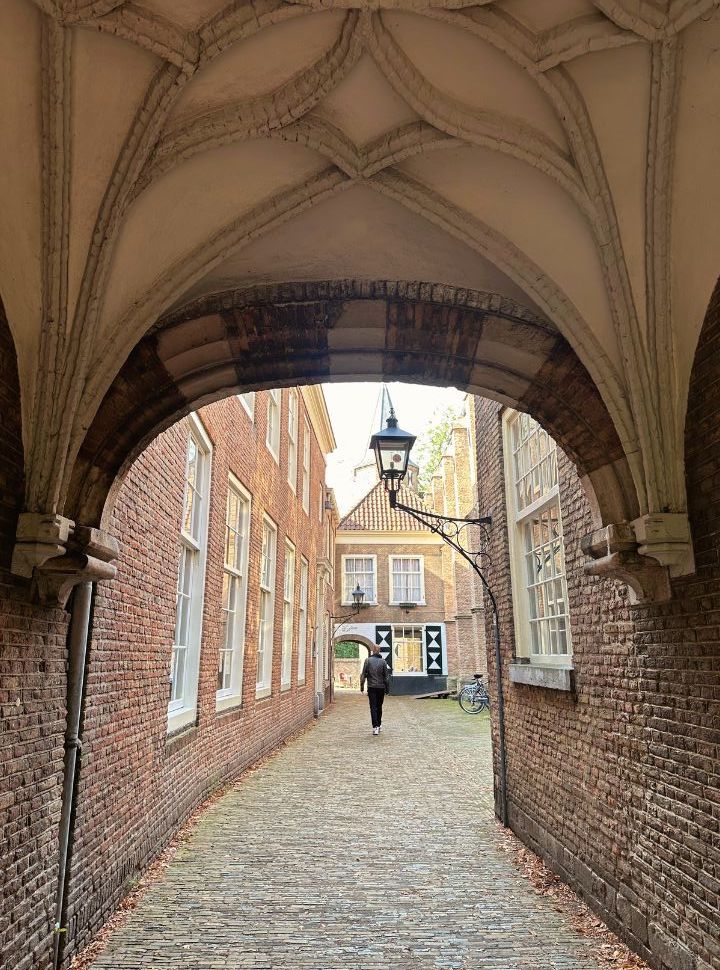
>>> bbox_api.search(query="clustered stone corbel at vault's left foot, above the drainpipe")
[12,512,118,607]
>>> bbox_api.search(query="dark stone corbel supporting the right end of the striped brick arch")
[582,522,671,603]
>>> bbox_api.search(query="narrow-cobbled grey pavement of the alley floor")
[94,695,599,970]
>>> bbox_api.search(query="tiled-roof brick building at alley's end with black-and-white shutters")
[334,398,485,694]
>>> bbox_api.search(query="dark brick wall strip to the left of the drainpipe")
[0,304,67,970]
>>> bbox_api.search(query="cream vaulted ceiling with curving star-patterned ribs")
[0,0,720,532]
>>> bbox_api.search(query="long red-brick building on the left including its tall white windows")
[3,387,337,967]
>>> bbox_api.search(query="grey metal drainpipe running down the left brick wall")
[53,583,93,970]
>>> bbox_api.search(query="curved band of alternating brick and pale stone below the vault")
[68,280,638,525]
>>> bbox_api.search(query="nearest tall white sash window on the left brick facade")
[168,415,211,730]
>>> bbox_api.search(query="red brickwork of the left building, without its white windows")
[60,391,332,964]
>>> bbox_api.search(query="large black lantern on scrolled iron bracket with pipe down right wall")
[370,408,508,826]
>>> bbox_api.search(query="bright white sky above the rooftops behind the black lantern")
[323,383,465,515]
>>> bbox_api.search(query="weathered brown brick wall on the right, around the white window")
[476,294,720,970]
